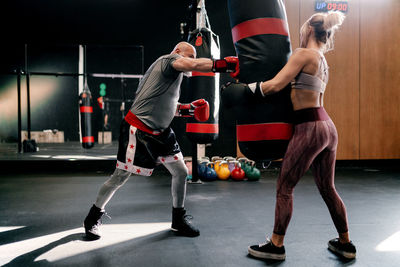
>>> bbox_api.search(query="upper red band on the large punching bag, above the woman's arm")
[232,18,289,43]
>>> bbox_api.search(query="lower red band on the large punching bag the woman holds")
[236,123,293,142]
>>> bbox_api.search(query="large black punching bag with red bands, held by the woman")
[221,0,293,160]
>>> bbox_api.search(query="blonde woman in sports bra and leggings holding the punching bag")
[248,12,356,260]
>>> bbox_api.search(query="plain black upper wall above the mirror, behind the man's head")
[0,0,234,74]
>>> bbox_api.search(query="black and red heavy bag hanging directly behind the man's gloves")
[180,28,220,144]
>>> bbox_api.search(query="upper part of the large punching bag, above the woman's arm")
[228,0,291,83]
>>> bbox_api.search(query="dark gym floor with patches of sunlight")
[0,146,400,267]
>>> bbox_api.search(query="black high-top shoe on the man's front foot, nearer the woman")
[171,208,200,237]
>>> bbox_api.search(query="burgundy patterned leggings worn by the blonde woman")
[274,108,348,235]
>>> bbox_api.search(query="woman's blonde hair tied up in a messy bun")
[300,11,345,53]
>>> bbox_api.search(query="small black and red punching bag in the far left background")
[79,91,94,148]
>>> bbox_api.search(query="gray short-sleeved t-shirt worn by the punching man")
[130,54,183,131]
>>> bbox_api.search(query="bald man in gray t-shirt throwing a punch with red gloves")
[84,42,239,239]
